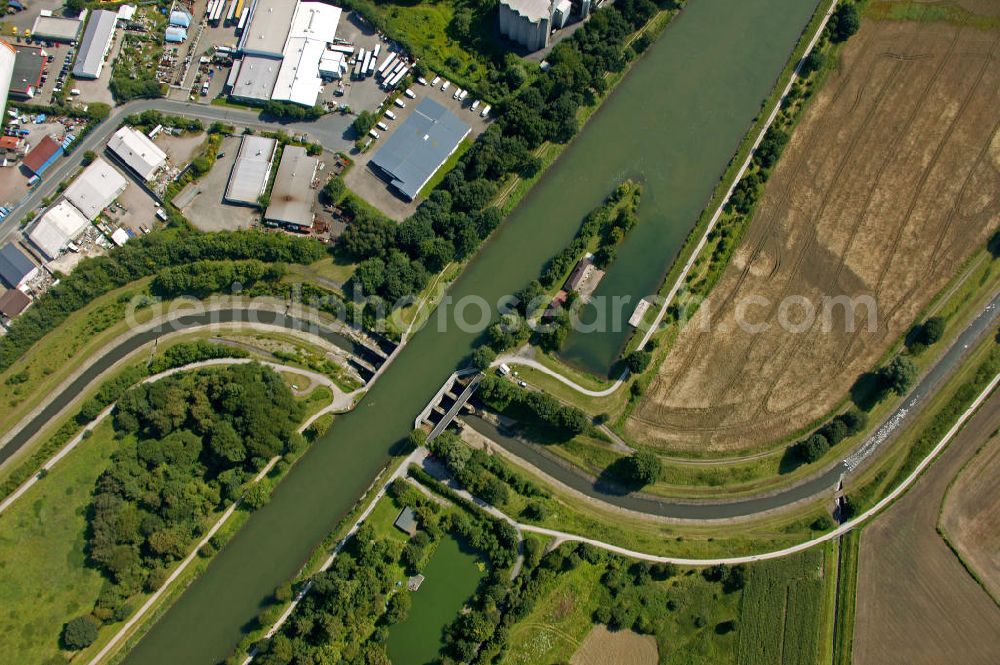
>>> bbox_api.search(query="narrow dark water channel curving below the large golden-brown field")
[465,293,1000,520]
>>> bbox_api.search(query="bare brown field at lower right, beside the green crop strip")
[853,386,1000,665]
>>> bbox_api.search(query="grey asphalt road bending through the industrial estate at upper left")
[0,99,354,244]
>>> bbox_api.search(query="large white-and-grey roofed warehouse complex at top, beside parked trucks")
[230,0,341,106]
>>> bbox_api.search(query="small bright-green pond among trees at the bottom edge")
[388,537,482,665]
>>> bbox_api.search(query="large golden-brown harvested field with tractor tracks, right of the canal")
[626,20,1000,452]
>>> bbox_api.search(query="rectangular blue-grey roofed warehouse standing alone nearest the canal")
[368,98,472,201]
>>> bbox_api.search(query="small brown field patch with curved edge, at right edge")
[939,433,1000,598]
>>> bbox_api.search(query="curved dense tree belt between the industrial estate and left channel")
[0,229,325,371]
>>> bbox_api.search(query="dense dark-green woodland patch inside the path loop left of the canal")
[87,363,303,621]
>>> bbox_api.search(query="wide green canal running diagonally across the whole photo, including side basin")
[125,0,816,665]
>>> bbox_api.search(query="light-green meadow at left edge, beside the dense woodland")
[0,421,117,663]
